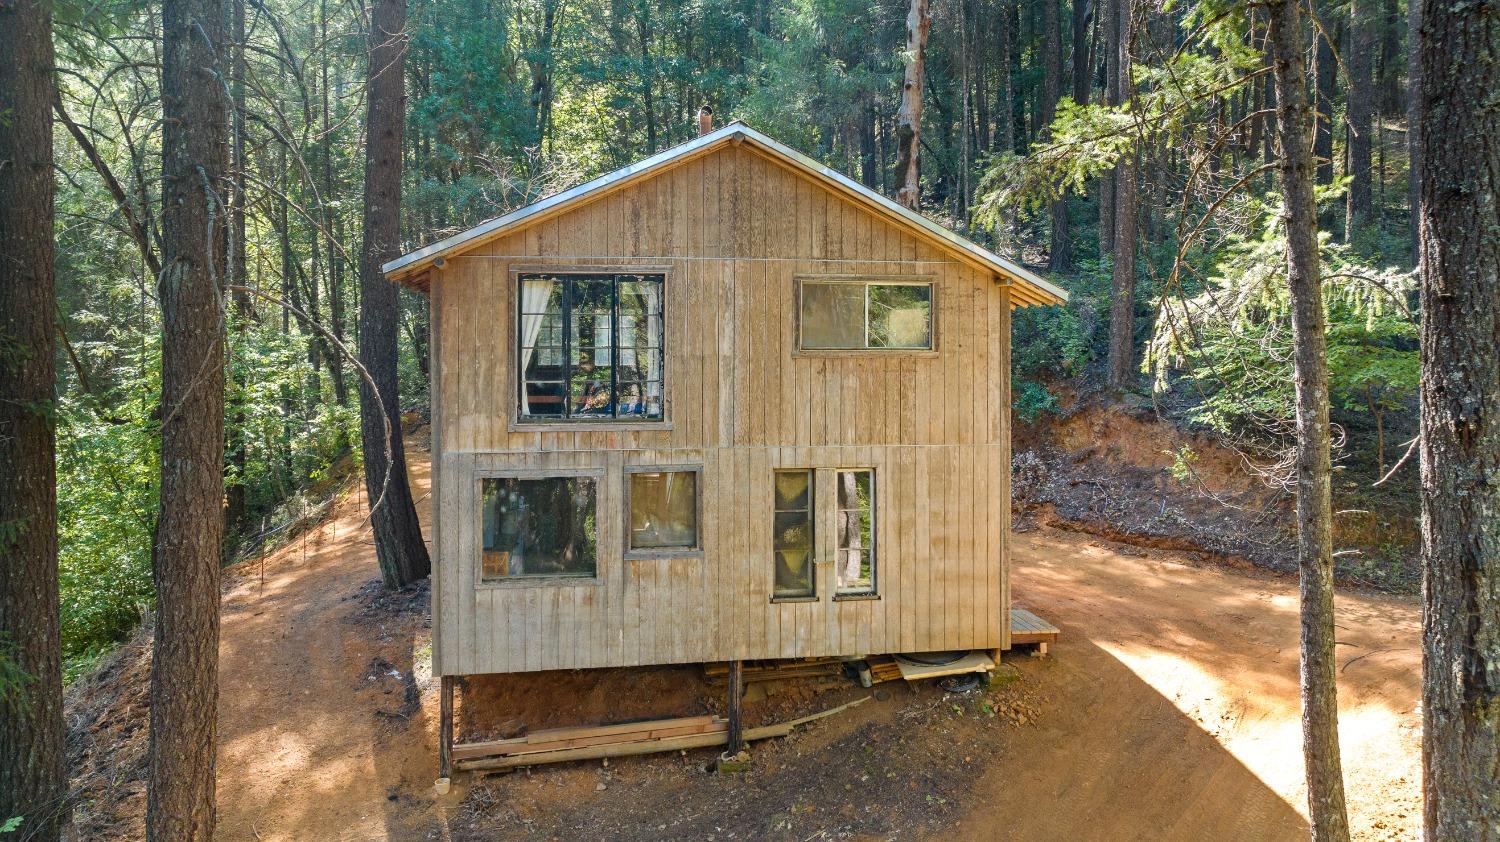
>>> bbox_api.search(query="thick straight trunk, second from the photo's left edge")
[146,0,230,842]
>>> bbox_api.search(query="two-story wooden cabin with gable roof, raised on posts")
[384,123,1067,768]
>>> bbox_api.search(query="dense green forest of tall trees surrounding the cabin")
[0,0,1500,839]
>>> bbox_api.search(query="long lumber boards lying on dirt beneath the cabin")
[453,696,869,770]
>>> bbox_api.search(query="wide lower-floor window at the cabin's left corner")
[480,476,599,582]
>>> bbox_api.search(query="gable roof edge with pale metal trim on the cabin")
[381,122,1068,306]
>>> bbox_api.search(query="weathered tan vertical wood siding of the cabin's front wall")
[431,147,1010,674]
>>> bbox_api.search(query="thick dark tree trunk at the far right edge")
[1418,0,1500,840]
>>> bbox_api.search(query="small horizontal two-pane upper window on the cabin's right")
[798,279,933,351]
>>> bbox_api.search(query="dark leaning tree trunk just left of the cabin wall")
[360,0,432,588]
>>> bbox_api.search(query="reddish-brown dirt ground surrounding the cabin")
[72,453,1421,842]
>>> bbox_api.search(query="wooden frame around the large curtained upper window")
[503,263,672,432]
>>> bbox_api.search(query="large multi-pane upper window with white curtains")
[518,273,663,422]
